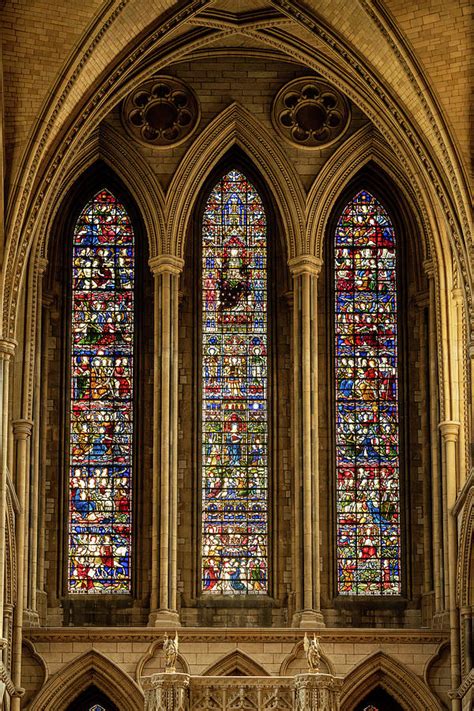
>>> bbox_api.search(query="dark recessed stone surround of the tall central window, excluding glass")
[180,146,289,608]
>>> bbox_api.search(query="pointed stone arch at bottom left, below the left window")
[30,650,144,711]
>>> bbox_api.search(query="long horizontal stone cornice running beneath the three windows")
[24,626,449,644]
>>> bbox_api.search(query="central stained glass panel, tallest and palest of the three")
[201,170,268,595]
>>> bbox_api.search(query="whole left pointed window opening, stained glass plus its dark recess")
[39,161,153,624]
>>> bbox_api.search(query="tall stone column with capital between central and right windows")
[289,255,324,628]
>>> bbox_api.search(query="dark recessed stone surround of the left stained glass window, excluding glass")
[47,160,149,624]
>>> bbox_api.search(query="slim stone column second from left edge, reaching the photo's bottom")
[11,419,33,711]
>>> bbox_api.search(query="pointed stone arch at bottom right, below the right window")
[341,652,442,711]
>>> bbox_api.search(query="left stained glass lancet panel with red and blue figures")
[69,190,134,593]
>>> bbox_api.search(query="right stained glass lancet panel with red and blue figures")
[335,191,400,595]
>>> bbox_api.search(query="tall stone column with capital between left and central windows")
[149,254,184,627]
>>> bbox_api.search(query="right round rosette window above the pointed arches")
[272,78,350,148]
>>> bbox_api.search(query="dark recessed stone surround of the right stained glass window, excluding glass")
[323,162,420,611]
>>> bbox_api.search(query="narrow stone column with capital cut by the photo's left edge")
[0,339,16,644]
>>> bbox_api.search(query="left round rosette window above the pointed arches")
[122,76,199,148]
